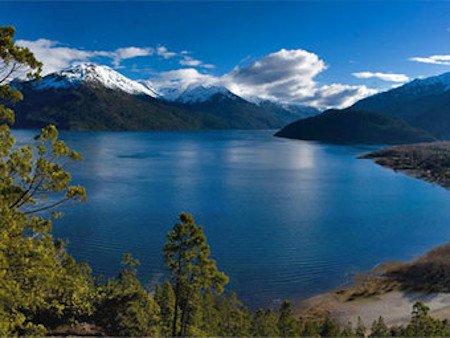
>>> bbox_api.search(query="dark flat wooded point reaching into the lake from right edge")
[360,141,450,189]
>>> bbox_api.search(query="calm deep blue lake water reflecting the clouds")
[17,130,450,307]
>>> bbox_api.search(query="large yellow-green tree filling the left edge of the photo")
[0,26,89,335]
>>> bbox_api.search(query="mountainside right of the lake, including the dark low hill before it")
[276,73,450,144]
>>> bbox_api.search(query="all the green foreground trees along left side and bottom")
[0,27,448,337]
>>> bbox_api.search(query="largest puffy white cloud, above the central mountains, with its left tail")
[152,49,376,108]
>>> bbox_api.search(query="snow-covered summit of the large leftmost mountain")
[29,63,158,97]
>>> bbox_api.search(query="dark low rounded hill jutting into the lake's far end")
[275,109,434,144]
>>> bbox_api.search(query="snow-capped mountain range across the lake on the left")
[8,63,319,130]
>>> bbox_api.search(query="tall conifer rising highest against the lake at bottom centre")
[163,213,228,336]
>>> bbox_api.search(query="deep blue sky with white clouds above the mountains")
[0,1,450,107]
